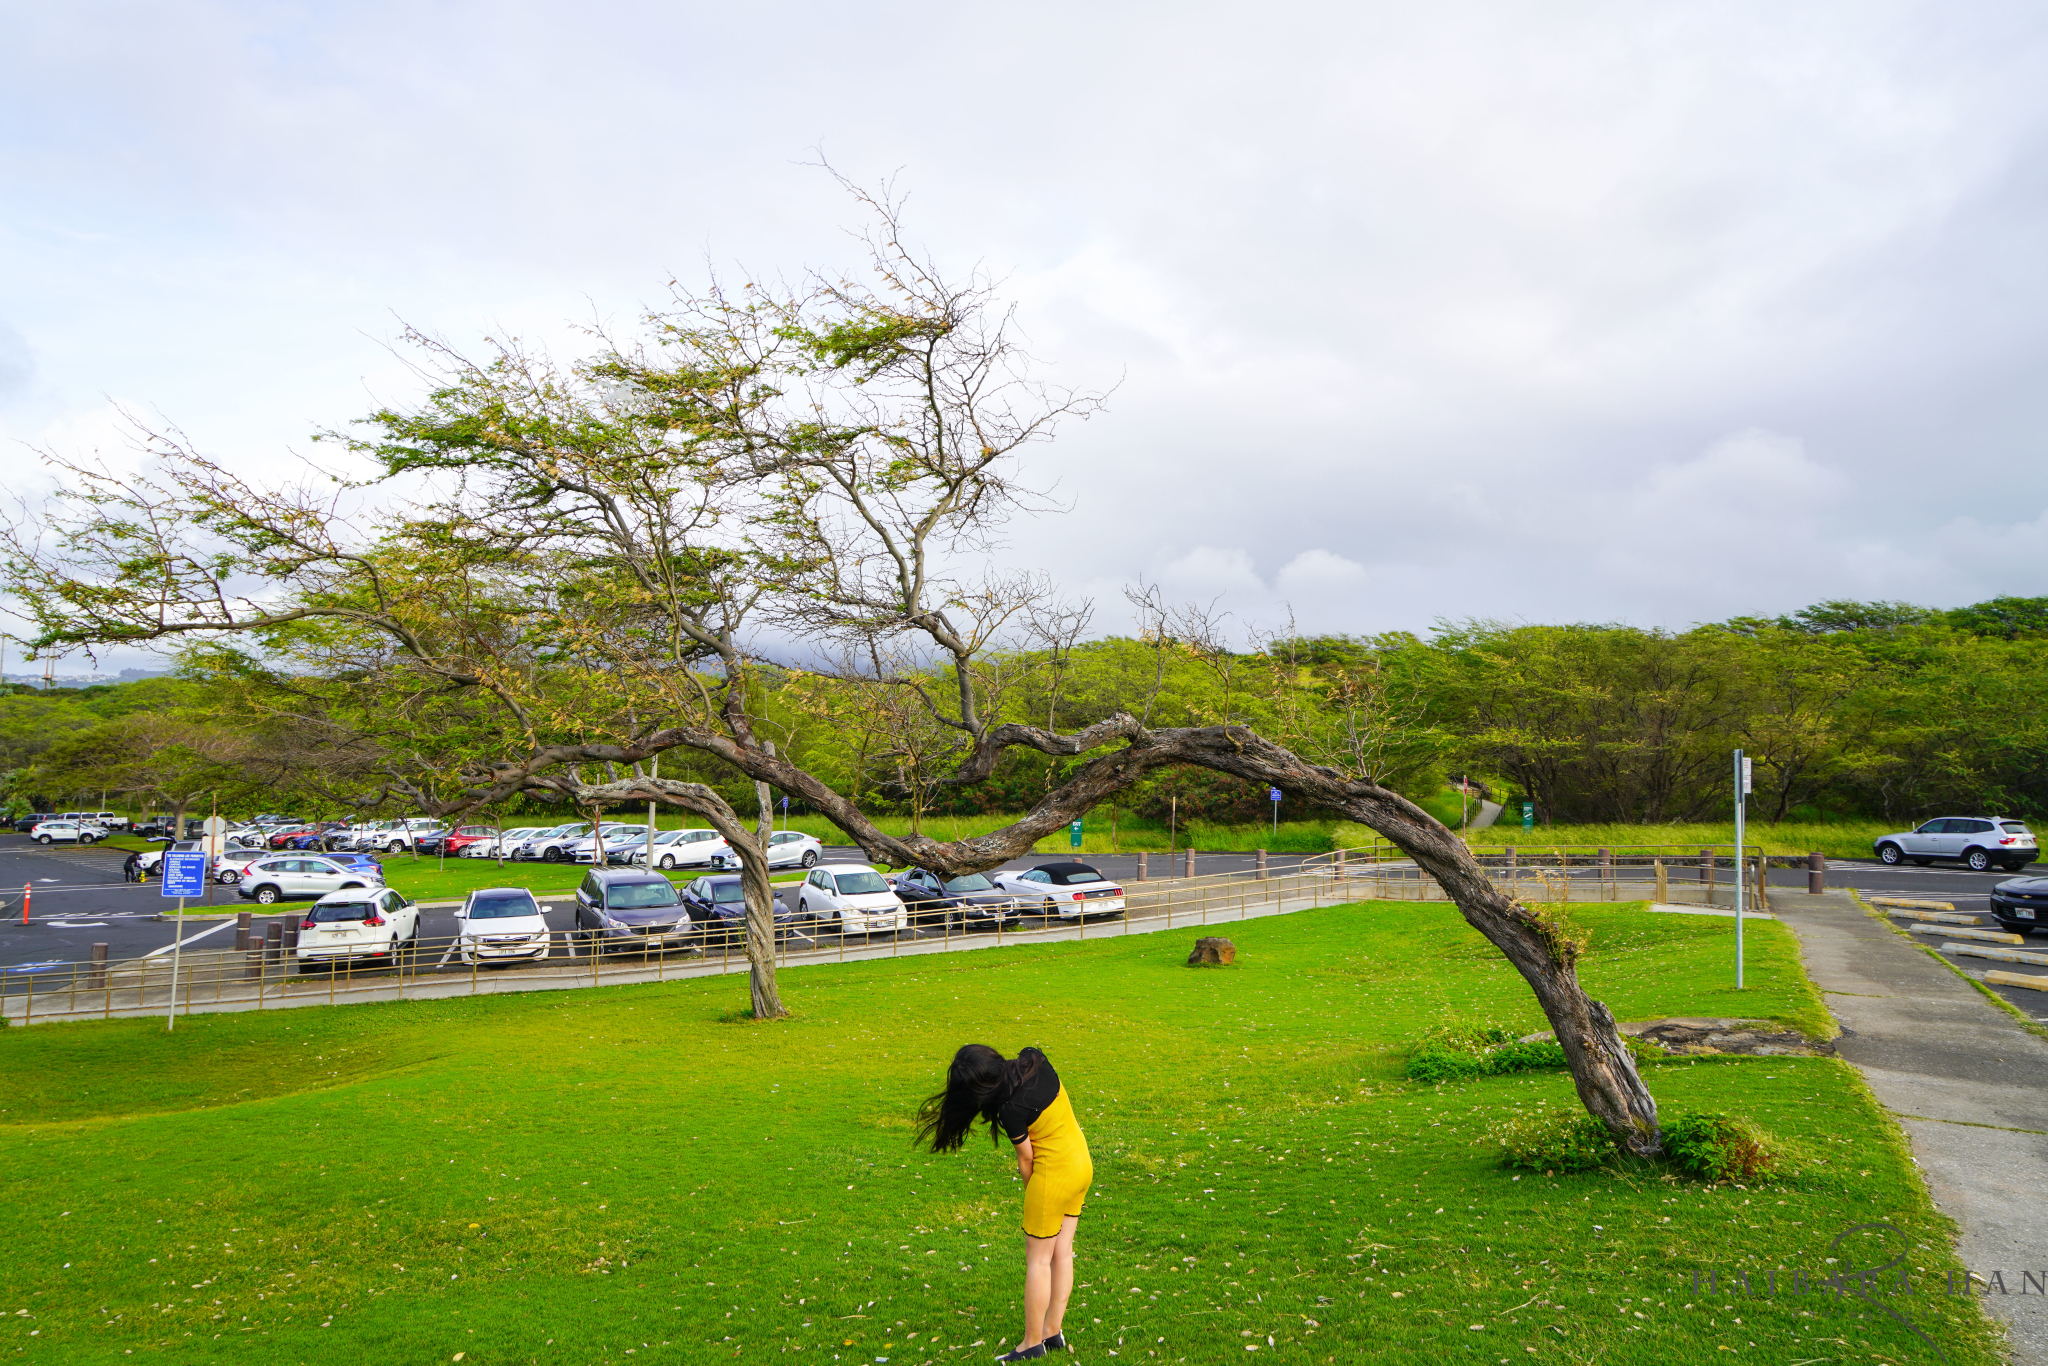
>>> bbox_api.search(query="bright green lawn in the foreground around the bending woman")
[0,903,1997,1366]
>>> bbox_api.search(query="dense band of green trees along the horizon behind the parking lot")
[0,598,2048,823]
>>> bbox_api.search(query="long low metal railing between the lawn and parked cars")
[0,846,1761,1024]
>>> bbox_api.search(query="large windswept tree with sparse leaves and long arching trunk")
[6,195,1659,1153]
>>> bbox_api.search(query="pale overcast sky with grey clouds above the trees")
[0,0,2048,667]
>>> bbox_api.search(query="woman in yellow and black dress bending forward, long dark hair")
[918,1044,1096,1362]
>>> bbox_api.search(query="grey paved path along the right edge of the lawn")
[1769,889,2048,1366]
